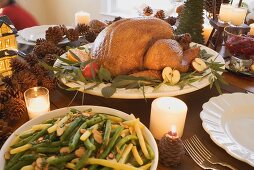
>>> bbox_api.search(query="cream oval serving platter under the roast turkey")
[54,43,225,99]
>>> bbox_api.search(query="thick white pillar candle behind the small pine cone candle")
[150,97,187,140]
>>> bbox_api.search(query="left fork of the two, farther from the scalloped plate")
[183,139,218,170]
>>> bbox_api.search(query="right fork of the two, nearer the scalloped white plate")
[190,135,237,170]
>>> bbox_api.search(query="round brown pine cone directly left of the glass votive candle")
[4,98,27,120]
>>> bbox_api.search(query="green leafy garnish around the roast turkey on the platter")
[40,44,227,98]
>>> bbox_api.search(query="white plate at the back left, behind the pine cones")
[18,25,71,44]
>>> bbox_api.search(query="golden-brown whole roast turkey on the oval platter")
[91,17,199,79]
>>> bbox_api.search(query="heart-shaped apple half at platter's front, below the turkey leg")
[162,67,181,85]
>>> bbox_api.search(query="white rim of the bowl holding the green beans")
[0,105,159,170]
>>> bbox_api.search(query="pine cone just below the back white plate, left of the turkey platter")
[33,41,58,59]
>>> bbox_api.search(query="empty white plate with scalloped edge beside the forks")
[200,93,254,166]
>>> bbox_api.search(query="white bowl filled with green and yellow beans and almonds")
[0,105,159,170]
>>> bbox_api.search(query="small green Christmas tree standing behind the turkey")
[176,0,204,44]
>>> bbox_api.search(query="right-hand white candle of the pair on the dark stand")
[230,7,247,26]
